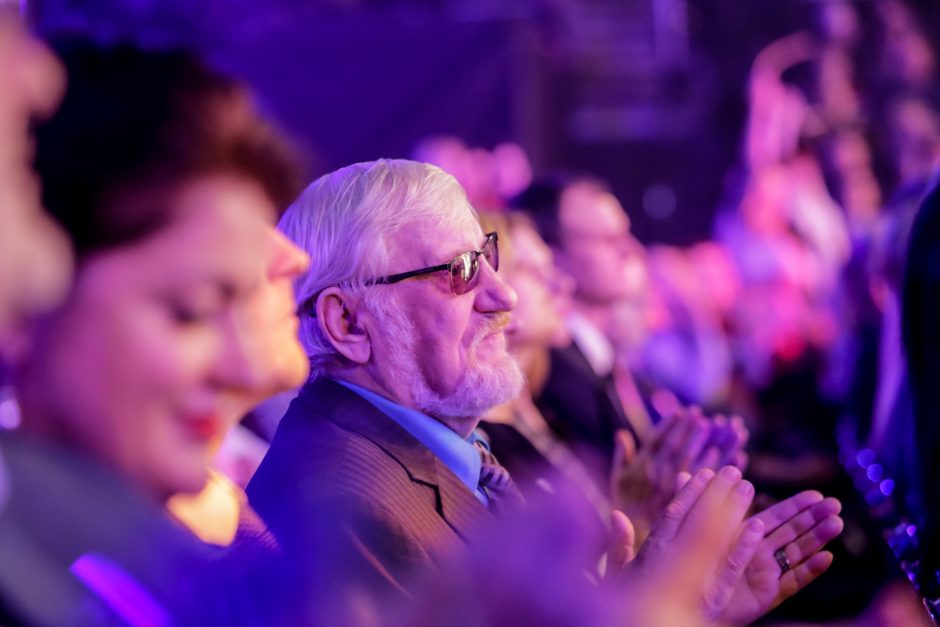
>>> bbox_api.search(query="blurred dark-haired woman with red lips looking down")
[0,43,305,624]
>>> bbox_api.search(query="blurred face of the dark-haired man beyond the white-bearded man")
[558,183,640,305]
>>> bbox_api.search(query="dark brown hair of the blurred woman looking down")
[36,40,300,262]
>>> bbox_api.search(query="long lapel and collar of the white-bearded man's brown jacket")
[298,377,492,540]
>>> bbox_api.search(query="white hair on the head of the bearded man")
[278,159,476,375]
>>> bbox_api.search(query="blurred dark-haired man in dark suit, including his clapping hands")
[514,177,746,541]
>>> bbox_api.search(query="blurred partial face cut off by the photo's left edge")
[0,15,71,349]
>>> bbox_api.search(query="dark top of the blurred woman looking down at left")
[0,432,248,625]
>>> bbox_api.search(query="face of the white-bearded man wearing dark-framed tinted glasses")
[367,205,522,435]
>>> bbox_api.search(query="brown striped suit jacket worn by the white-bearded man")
[248,377,491,590]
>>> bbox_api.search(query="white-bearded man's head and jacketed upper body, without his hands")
[248,161,522,585]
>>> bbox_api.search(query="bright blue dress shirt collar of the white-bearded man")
[336,379,489,505]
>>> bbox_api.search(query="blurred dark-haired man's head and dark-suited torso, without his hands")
[513,177,646,476]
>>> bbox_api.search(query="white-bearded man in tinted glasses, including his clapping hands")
[248,160,841,624]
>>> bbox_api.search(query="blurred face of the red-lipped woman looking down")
[18,175,290,498]
